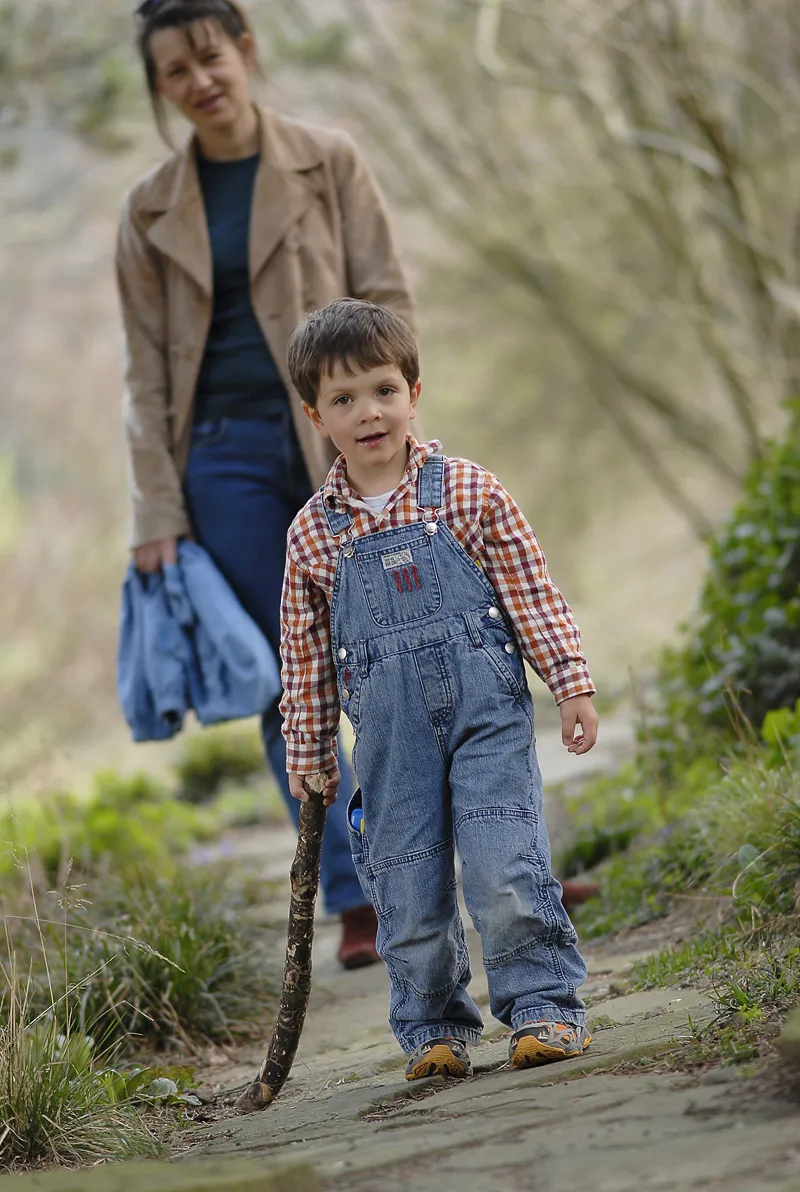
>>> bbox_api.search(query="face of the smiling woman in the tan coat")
[150,20,255,135]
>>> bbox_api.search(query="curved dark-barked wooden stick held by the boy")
[236,774,328,1113]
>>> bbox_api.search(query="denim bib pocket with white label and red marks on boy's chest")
[354,532,441,627]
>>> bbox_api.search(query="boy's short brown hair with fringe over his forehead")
[287,298,420,409]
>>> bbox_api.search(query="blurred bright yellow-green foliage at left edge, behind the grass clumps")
[0,770,215,884]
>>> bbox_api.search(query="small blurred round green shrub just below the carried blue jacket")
[175,725,265,803]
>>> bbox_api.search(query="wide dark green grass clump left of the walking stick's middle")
[10,870,280,1049]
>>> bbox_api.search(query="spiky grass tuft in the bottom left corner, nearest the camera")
[0,1015,163,1171]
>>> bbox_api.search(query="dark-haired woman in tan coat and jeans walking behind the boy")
[117,0,419,968]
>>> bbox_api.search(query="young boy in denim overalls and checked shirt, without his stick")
[281,299,597,1080]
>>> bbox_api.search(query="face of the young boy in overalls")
[305,364,422,476]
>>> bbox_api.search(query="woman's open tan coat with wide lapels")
[117,111,413,546]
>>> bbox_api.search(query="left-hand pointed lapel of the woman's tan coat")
[148,142,213,297]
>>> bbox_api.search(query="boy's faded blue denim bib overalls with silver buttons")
[324,454,587,1053]
